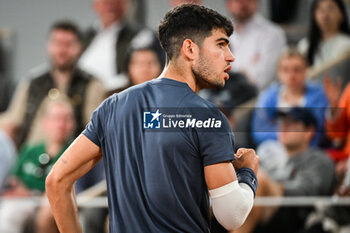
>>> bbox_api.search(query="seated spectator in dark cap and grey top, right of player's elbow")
[235,107,336,233]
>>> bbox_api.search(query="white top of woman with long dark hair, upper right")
[298,33,350,69]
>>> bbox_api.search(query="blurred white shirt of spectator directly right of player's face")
[230,14,286,90]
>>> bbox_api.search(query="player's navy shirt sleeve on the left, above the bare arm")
[83,97,112,147]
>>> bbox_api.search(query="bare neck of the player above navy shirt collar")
[161,61,200,93]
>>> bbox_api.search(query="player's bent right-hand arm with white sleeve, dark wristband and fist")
[204,149,259,230]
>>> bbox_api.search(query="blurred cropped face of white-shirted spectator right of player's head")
[226,0,259,22]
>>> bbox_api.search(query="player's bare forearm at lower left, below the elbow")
[46,174,82,233]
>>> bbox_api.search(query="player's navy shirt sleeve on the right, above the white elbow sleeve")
[197,109,234,166]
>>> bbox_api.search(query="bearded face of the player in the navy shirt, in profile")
[192,30,235,88]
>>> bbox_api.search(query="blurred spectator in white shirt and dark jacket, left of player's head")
[79,0,162,91]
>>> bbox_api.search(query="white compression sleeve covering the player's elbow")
[209,180,254,230]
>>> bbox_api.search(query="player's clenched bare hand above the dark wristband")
[233,148,259,174]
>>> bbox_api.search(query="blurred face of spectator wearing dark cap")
[278,117,313,150]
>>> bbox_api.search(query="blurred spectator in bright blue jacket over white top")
[252,49,328,146]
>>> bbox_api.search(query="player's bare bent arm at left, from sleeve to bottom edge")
[46,134,102,233]
